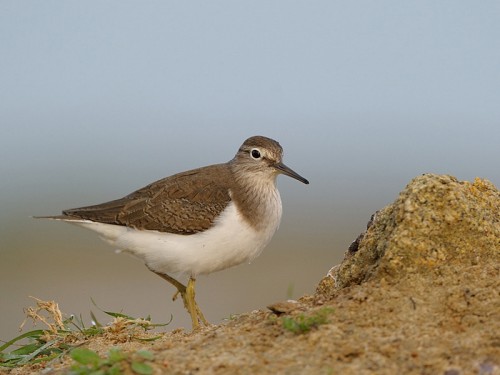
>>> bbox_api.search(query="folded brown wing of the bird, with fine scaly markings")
[63,164,231,234]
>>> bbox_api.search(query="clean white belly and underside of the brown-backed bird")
[68,201,281,276]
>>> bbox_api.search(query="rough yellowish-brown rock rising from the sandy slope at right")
[319,174,500,294]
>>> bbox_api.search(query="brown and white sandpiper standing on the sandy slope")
[36,136,309,331]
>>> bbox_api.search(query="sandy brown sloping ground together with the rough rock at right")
[0,175,500,375]
